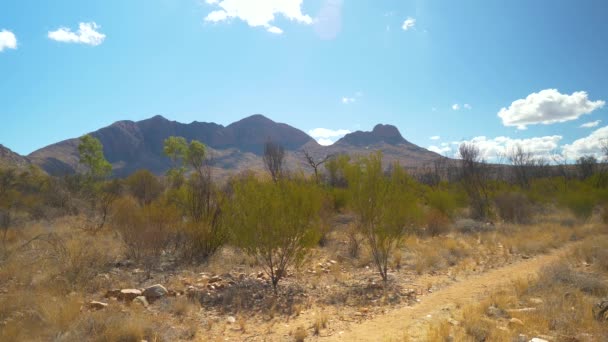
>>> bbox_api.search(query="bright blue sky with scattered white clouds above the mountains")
[0,0,608,159]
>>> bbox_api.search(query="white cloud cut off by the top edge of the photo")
[205,0,313,34]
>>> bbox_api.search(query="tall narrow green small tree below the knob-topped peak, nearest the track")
[348,152,420,284]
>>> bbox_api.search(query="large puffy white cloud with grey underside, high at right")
[498,89,605,129]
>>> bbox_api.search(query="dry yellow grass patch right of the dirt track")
[428,236,608,341]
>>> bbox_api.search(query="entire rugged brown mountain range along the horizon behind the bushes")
[0,114,440,177]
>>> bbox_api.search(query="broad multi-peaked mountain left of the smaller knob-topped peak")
[29,115,317,176]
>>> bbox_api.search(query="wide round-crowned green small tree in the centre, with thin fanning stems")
[227,177,321,294]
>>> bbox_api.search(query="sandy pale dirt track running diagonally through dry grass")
[320,244,574,341]
